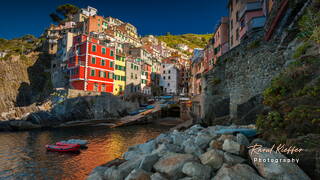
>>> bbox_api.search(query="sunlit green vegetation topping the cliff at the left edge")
[0,35,41,59]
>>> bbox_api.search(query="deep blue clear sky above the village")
[0,0,227,39]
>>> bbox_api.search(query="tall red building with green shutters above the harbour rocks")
[68,35,114,93]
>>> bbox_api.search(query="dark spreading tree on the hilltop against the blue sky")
[49,4,79,23]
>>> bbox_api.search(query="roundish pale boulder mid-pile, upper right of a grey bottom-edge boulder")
[200,149,223,170]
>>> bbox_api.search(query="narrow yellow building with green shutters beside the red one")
[113,52,126,95]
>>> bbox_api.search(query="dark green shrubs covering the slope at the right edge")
[256,43,320,142]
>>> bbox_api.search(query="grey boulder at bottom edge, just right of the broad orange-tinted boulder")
[182,162,211,180]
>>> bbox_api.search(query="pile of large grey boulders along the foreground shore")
[87,125,310,180]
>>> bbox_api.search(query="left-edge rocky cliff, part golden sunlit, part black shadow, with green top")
[0,38,52,119]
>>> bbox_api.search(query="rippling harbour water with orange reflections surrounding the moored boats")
[0,125,169,179]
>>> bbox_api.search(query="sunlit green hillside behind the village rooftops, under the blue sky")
[157,34,212,53]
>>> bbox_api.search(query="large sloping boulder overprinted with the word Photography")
[249,148,310,180]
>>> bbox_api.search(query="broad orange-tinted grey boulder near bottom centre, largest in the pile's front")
[153,153,197,179]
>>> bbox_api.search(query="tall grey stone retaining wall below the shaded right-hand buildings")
[202,32,285,124]
